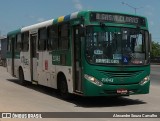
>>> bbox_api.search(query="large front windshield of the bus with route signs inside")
[85,26,149,66]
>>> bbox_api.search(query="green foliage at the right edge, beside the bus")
[151,41,160,58]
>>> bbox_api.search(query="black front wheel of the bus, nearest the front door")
[57,72,69,99]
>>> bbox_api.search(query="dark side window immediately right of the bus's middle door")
[38,28,47,51]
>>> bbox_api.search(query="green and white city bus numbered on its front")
[7,11,151,97]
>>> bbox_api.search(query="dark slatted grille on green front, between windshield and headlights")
[98,70,143,78]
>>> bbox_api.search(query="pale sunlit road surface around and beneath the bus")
[0,65,160,121]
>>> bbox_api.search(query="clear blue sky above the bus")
[0,0,160,43]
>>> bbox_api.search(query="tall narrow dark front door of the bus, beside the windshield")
[73,26,82,92]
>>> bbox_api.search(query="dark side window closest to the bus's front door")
[59,24,69,50]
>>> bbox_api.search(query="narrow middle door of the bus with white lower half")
[30,34,37,84]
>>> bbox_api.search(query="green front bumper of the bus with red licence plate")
[84,80,150,96]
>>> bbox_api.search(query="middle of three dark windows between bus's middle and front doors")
[47,25,58,50]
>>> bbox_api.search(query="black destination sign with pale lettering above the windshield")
[90,12,145,26]
